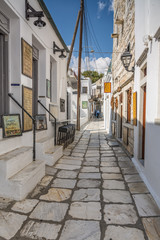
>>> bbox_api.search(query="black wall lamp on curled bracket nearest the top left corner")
[26,0,46,28]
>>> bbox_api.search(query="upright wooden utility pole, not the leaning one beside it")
[77,0,84,131]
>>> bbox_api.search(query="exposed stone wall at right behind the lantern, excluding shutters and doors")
[112,0,135,154]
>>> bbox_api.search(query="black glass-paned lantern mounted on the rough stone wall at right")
[121,43,134,72]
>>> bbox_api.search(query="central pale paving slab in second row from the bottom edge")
[69,202,101,220]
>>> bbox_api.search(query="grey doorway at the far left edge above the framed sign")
[0,32,9,127]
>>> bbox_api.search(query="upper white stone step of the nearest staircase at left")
[0,147,33,179]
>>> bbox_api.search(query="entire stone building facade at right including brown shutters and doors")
[111,0,135,155]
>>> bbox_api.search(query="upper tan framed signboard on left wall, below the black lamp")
[22,39,33,78]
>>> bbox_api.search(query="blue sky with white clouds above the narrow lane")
[44,0,113,73]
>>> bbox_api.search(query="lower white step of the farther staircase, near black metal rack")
[43,146,63,166]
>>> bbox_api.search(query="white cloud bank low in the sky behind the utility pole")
[70,55,111,74]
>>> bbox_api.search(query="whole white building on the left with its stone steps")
[0,0,68,200]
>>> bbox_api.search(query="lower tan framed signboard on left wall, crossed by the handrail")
[23,86,32,132]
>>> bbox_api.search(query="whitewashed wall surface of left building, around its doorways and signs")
[0,0,67,141]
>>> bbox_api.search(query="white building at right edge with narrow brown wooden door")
[133,0,160,206]
